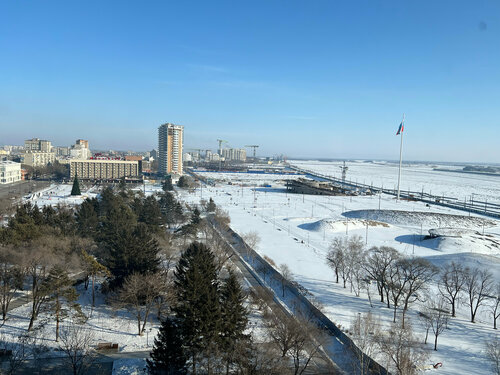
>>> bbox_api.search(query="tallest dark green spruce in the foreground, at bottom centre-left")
[173,242,221,374]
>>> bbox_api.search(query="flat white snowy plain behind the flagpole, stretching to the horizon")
[289,160,500,204]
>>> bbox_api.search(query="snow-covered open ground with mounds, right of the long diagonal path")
[179,170,500,375]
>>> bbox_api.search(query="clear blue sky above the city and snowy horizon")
[0,0,500,162]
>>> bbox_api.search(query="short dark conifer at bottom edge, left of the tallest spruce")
[147,318,187,375]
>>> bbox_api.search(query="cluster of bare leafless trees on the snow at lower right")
[326,236,500,374]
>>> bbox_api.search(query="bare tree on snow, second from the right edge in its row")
[465,268,493,323]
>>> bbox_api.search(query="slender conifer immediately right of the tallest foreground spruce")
[220,270,250,374]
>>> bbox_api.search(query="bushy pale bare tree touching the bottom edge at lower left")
[59,324,96,375]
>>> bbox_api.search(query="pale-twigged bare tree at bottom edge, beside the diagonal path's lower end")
[350,312,380,375]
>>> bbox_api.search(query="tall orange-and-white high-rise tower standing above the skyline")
[158,123,184,175]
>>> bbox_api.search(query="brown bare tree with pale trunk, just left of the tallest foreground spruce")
[118,273,165,336]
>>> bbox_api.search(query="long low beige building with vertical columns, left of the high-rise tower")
[70,159,140,180]
